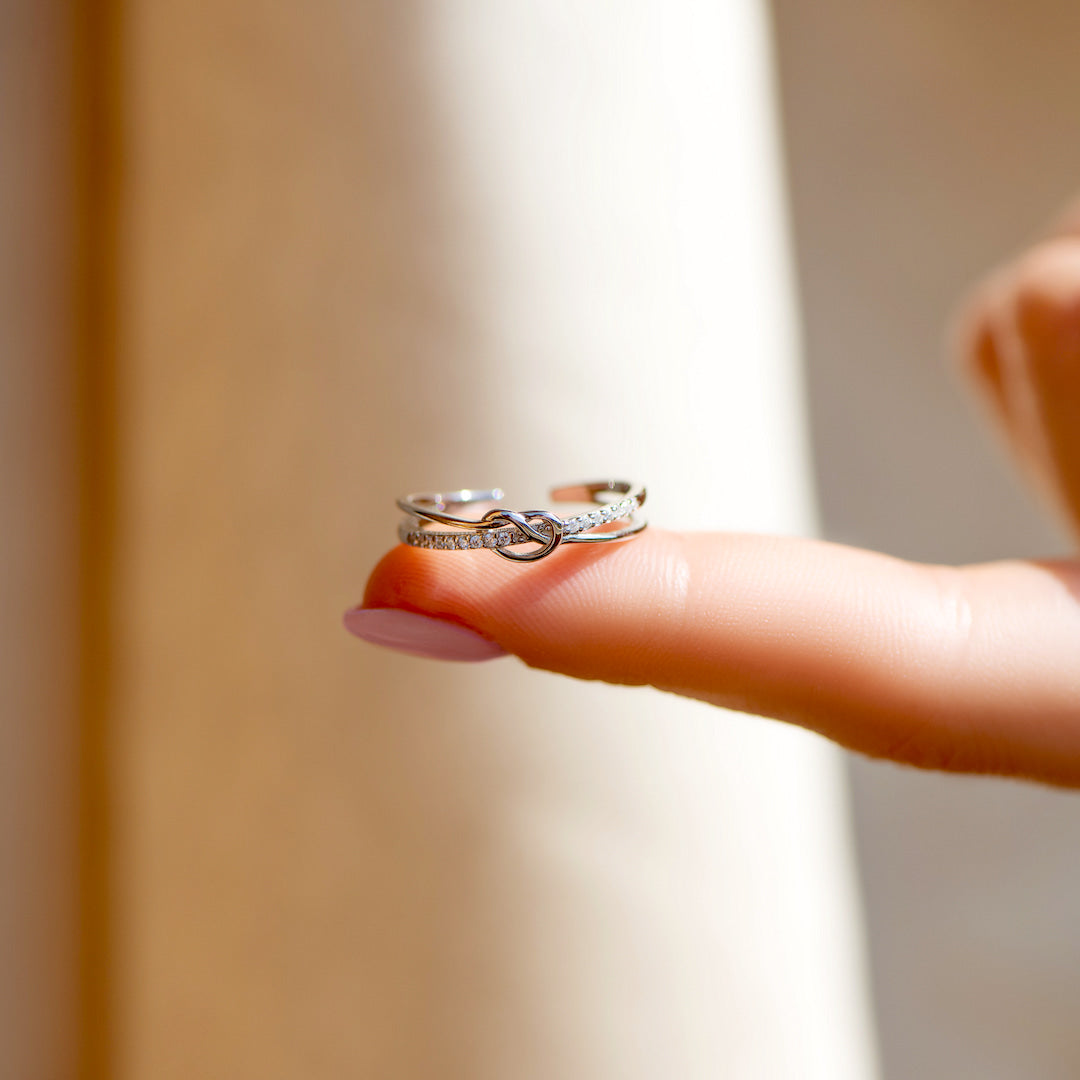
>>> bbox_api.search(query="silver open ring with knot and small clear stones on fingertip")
[397,480,648,563]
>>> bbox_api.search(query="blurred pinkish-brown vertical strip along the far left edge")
[0,0,79,1078]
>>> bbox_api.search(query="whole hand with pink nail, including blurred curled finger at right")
[346,230,1080,786]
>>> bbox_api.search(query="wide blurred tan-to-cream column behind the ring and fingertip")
[114,0,874,1080]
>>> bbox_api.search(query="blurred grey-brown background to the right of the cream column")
[772,0,1080,1080]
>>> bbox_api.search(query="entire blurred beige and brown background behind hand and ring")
[6,0,1080,1080]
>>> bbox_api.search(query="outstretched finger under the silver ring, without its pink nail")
[352,530,1080,784]
